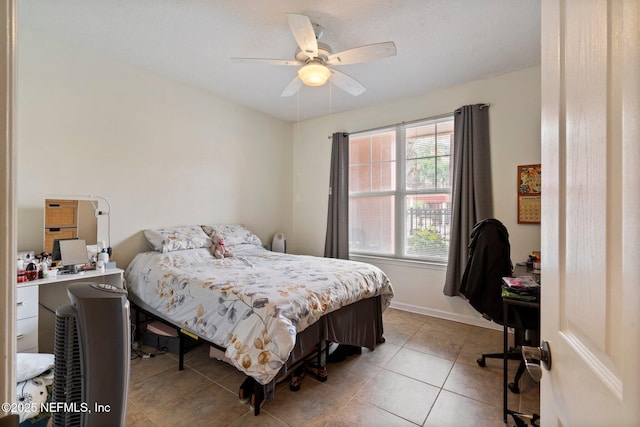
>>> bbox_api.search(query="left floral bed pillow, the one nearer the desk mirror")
[144,225,212,253]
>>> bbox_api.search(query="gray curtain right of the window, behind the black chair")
[444,104,493,296]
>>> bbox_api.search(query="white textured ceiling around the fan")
[18,0,540,121]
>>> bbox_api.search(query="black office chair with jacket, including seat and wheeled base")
[460,218,539,393]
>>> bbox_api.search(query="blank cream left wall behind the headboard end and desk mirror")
[17,28,292,267]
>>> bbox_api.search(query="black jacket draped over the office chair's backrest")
[460,218,513,323]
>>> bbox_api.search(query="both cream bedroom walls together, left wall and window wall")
[17,29,544,326]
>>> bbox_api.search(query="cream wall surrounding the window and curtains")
[290,67,544,326]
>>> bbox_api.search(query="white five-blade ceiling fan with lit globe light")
[231,13,396,96]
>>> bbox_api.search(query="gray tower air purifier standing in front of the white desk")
[49,283,131,427]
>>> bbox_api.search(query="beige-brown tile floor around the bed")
[127,309,539,427]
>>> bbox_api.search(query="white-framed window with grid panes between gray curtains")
[349,115,453,262]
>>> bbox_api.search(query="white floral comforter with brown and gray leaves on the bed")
[125,246,393,384]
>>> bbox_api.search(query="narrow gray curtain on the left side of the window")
[324,133,349,259]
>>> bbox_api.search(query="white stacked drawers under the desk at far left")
[16,285,38,353]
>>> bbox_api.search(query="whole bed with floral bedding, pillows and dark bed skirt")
[125,225,393,412]
